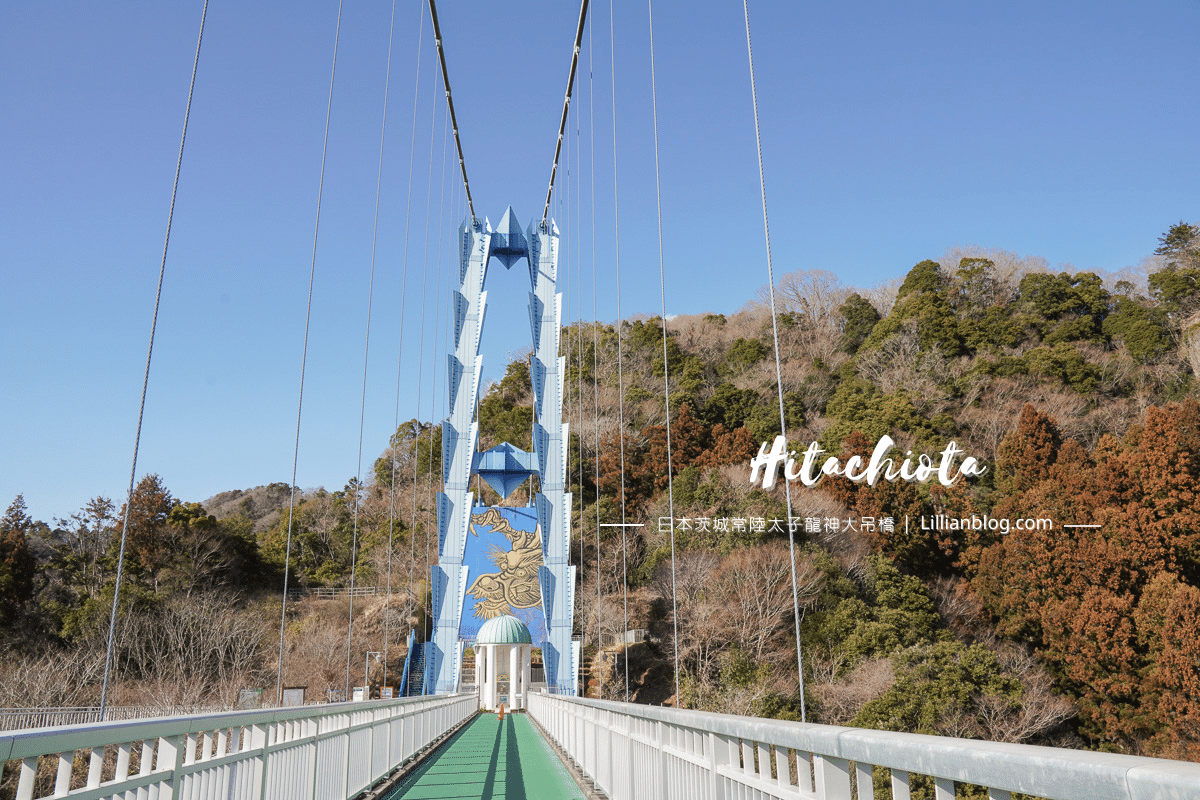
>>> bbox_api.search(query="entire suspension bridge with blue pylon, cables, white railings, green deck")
[0,0,1200,800]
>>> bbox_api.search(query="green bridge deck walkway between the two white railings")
[384,714,583,800]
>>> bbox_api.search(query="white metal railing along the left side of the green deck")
[0,694,478,800]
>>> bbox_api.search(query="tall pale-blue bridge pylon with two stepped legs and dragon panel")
[425,206,580,694]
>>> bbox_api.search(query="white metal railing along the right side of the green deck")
[529,694,1200,800]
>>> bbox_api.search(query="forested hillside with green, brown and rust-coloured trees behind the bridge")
[0,222,1200,759]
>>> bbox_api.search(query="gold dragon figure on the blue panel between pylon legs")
[468,509,541,619]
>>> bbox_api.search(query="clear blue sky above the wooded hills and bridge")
[0,0,1200,521]
